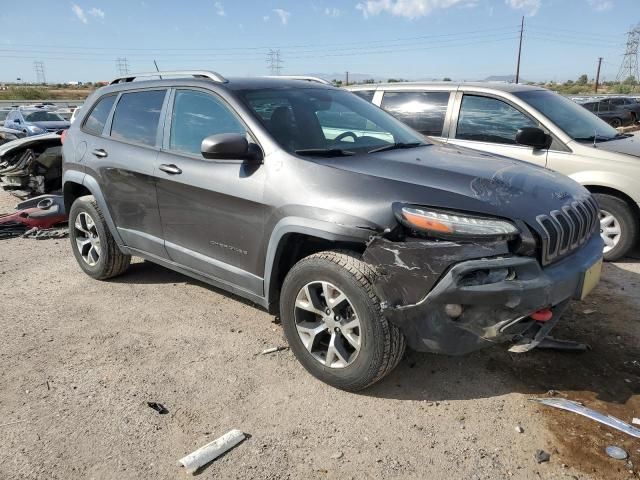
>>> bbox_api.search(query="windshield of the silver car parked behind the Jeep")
[514,90,618,141]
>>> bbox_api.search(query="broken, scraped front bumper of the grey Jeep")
[364,235,603,355]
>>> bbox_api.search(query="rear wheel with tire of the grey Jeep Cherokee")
[69,195,131,280]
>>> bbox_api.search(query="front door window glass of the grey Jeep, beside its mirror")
[169,90,246,154]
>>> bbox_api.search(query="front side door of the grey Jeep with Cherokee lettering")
[156,89,264,295]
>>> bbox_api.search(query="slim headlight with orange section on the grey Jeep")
[396,205,518,238]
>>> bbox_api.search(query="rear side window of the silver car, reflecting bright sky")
[381,92,449,136]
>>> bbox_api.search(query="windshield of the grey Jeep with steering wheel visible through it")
[239,88,426,156]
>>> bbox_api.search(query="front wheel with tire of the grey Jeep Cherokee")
[280,251,406,392]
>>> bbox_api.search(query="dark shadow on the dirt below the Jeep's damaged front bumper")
[363,259,640,404]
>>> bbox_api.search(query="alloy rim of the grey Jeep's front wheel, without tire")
[294,281,361,368]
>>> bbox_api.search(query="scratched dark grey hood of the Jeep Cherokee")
[310,145,589,228]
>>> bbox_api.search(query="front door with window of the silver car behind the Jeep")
[449,92,548,167]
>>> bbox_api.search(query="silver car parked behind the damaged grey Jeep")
[348,82,640,260]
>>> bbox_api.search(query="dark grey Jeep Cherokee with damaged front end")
[63,72,603,391]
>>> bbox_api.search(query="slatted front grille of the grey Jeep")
[536,197,600,265]
